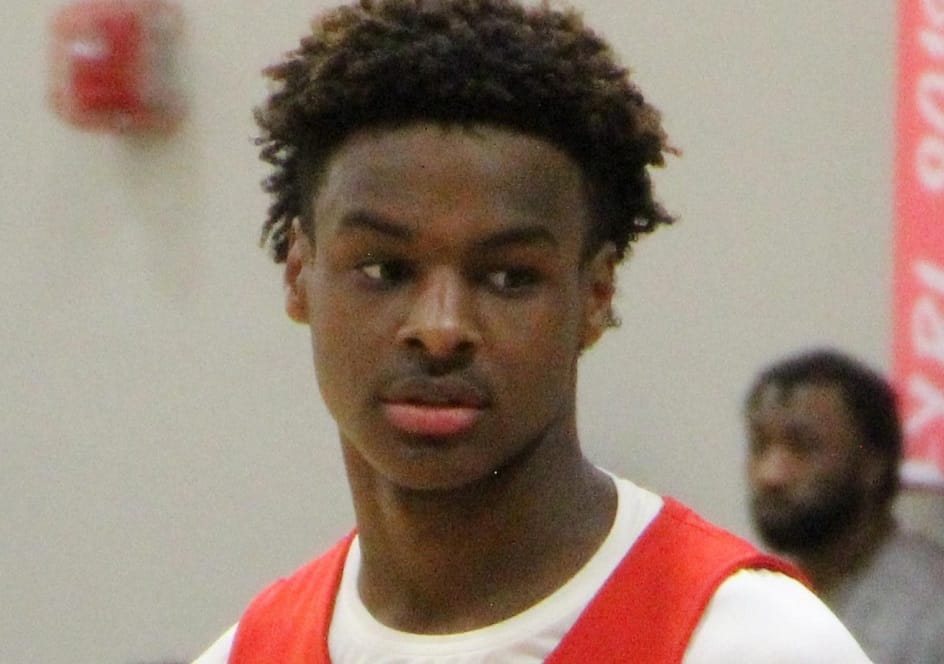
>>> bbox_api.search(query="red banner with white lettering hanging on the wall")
[893,0,944,489]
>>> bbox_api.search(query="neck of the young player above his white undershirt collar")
[346,426,616,633]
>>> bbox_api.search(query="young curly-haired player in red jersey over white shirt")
[192,0,867,664]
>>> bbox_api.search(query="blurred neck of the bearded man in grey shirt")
[794,509,894,597]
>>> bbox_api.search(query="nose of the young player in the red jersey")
[397,268,482,359]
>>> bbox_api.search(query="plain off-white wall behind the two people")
[0,0,916,664]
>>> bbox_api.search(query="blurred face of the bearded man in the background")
[747,384,877,553]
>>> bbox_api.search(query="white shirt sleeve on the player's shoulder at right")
[685,569,869,664]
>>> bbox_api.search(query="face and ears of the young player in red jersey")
[286,124,614,489]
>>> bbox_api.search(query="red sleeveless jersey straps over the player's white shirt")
[229,498,805,664]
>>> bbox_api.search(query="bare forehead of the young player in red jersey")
[314,123,590,236]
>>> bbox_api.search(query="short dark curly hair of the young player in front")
[255,0,676,262]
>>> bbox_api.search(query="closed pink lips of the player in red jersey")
[381,378,488,437]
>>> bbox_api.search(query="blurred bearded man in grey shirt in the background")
[747,350,944,664]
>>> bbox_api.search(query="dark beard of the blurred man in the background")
[751,481,864,554]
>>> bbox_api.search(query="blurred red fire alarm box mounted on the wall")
[50,0,184,132]
